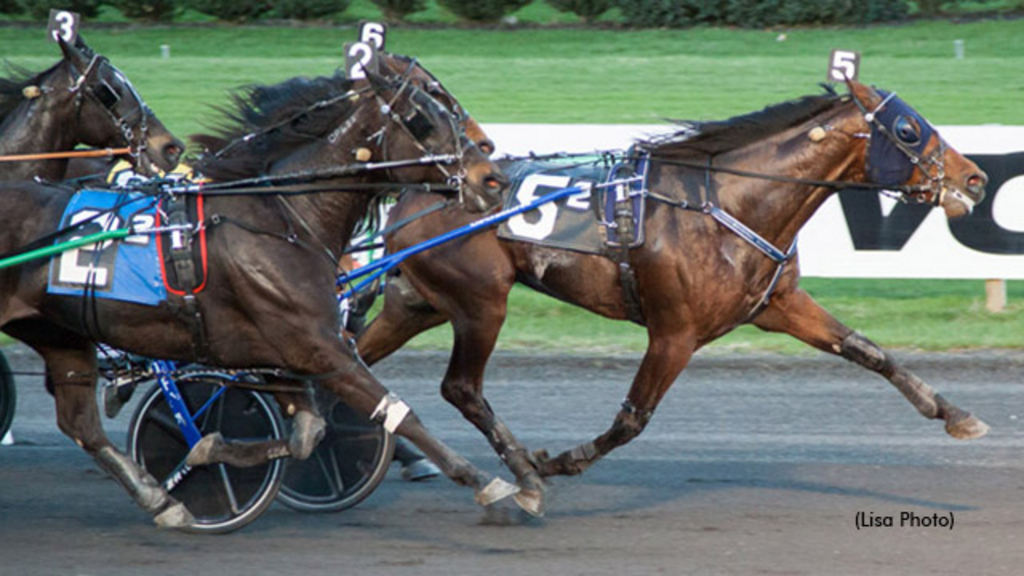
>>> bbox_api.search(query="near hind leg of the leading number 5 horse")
[441,303,544,516]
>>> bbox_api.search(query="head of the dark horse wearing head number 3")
[56,37,184,173]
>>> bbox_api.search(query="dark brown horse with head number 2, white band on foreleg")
[0,61,514,528]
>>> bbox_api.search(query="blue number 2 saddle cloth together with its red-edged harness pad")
[47,190,207,305]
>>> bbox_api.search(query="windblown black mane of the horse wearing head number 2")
[189,74,354,180]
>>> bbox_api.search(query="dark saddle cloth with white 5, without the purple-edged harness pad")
[498,157,642,254]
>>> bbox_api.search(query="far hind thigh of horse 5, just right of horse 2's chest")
[356,276,447,366]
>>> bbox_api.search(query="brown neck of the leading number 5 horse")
[712,108,866,248]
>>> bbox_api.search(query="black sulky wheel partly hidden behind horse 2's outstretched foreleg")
[278,389,394,512]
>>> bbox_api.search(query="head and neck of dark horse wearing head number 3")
[0,37,184,180]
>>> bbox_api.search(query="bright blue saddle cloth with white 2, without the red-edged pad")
[47,190,167,305]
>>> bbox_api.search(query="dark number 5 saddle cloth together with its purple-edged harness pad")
[498,153,647,255]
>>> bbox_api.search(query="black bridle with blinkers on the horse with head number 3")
[68,53,153,165]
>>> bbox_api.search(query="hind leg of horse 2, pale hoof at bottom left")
[11,325,195,528]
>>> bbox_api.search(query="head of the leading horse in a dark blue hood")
[848,81,988,218]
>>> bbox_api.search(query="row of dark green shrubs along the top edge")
[0,0,917,28]
